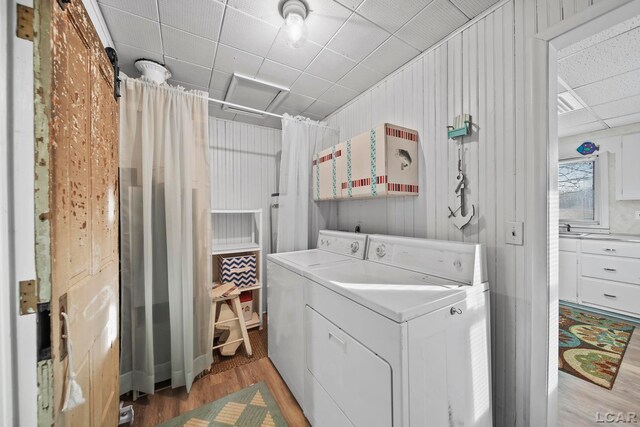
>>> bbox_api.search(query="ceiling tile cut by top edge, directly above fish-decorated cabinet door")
[358,0,430,33]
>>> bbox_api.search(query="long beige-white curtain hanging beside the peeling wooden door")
[120,78,212,393]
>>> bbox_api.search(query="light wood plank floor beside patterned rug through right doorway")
[558,325,640,427]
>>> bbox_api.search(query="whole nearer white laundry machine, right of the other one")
[302,235,492,427]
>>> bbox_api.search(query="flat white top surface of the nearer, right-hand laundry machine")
[304,261,487,322]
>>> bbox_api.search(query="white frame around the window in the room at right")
[558,151,609,231]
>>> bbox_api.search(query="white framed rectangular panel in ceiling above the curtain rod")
[222,73,289,118]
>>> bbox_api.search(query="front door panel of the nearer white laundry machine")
[305,306,392,427]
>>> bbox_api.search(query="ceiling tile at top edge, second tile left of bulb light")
[158,0,224,40]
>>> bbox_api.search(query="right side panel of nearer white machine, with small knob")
[408,291,492,427]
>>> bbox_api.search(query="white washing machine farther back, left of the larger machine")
[267,230,367,408]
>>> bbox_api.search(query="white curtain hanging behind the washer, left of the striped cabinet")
[277,114,340,252]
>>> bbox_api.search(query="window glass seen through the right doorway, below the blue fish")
[558,160,597,222]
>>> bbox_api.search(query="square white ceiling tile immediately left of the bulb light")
[220,8,278,57]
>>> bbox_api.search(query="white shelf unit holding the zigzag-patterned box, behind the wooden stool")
[211,209,264,329]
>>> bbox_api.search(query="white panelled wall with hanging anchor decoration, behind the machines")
[327,0,592,426]
